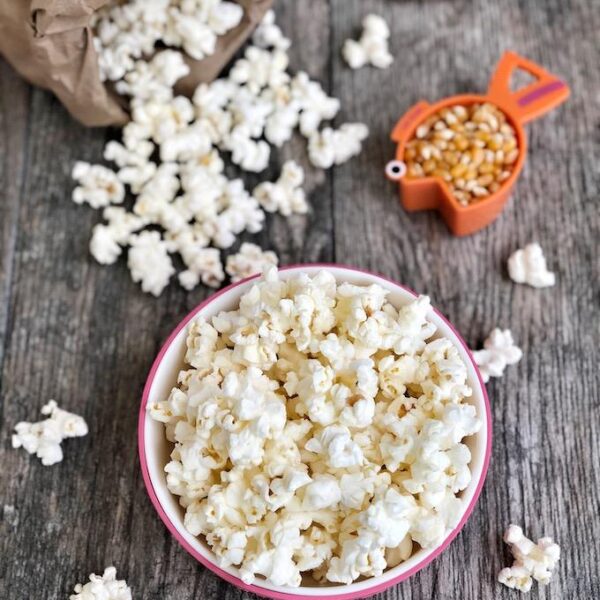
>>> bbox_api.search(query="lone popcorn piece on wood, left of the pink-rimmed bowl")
[12,400,88,466]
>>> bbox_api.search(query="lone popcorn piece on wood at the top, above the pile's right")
[342,15,394,69]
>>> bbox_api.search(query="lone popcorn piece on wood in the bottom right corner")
[498,525,560,592]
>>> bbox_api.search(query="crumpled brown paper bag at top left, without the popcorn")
[0,0,273,126]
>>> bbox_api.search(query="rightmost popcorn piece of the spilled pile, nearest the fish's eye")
[308,123,369,169]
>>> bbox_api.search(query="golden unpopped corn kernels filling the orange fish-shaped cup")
[404,102,519,206]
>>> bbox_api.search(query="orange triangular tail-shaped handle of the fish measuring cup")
[488,52,571,123]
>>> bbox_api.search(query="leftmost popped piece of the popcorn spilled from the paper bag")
[72,161,125,208]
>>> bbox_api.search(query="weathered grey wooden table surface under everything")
[0,0,600,600]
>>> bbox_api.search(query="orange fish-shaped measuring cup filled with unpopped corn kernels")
[386,52,569,235]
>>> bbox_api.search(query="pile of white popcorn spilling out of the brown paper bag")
[73,0,368,296]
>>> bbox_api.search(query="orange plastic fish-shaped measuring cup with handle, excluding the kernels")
[386,52,570,235]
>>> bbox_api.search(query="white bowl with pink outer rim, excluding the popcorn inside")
[138,264,492,600]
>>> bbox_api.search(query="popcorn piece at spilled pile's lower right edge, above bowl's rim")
[252,160,308,217]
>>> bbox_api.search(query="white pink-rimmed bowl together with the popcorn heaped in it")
[139,265,491,600]
